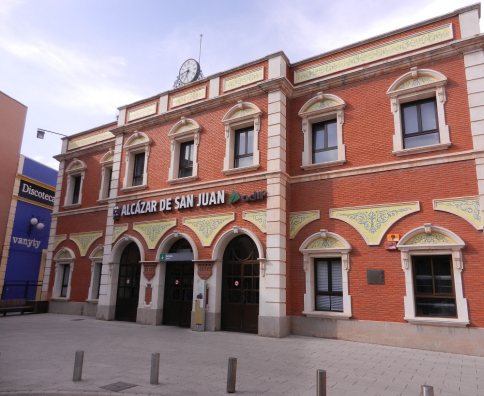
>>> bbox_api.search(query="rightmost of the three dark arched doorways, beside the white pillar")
[221,235,259,333]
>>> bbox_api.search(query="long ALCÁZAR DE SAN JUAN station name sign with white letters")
[113,190,267,219]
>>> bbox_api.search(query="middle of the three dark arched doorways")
[163,239,194,327]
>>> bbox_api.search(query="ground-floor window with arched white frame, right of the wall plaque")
[397,224,469,326]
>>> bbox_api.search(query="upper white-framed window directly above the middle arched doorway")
[168,117,201,183]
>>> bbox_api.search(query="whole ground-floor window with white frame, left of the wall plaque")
[299,230,352,319]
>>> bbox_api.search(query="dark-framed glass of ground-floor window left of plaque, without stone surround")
[314,258,343,312]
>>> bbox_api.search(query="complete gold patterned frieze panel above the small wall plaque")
[329,202,420,245]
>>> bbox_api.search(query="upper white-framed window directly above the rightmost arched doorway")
[222,100,262,174]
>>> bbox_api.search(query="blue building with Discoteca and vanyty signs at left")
[0,155,57,300]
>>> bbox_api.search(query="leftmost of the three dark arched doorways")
[114,242,141,322]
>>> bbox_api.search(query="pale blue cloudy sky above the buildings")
[0,0,482,167]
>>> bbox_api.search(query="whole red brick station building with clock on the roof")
[44,5,484,355]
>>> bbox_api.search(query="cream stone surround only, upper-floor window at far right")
[387,67,451,156]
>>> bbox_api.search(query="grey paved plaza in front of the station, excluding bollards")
[0,314,484,396]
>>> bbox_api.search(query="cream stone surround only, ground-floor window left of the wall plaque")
[299,230,352,319]
